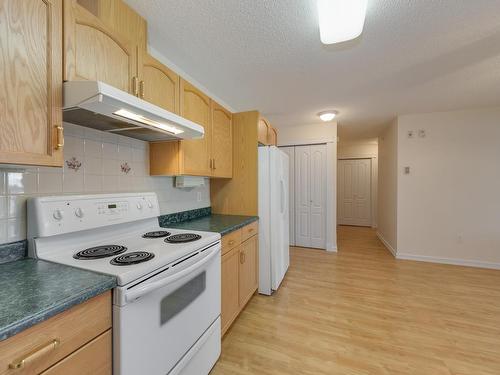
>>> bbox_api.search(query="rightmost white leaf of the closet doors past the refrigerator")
[310,145,326,249]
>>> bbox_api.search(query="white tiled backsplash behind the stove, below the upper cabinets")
[0,124,210,244]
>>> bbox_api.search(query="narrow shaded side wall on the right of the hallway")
[377,119,398,255]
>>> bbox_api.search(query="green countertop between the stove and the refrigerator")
[168,214,259,236]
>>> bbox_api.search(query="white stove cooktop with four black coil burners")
[34,226,220,286]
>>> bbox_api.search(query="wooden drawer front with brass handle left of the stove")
[0,291,111,375]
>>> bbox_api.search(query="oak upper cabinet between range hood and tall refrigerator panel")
[149,78,233,178]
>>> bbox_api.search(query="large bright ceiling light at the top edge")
[317,0,368,44]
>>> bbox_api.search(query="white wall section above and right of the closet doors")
[278,122,337,251]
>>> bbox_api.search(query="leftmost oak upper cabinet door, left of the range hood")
[0,0,63,166]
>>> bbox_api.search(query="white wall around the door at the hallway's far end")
[337,138,378,228]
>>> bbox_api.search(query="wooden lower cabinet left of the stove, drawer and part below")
[0,292,112,375]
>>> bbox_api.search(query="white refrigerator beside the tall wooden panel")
[259,146,290,295]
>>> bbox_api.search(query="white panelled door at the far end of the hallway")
[338,159,372,226]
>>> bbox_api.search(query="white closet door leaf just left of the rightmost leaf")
[295,146,311,247]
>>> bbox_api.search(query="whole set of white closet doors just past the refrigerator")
[295,145,326,249]
